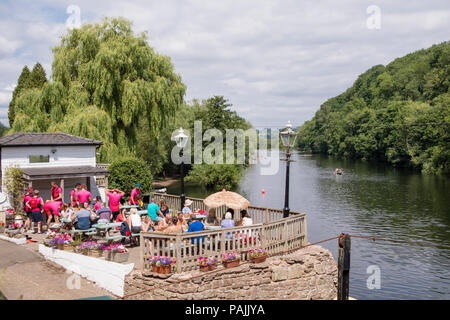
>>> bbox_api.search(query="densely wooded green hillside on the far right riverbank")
[298,41,450,174]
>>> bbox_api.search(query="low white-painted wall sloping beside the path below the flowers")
[39,244,134,297]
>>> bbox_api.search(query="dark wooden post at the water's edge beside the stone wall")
[337,233,350,300]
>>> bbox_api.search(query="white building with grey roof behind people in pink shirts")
[0,132,108,202]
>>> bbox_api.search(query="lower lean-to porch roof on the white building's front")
[22,166,108,180]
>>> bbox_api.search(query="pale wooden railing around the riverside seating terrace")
[140,194,307,273]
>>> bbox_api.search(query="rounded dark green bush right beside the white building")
[108,158,153,195]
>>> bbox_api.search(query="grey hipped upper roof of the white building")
[0,132,103,147]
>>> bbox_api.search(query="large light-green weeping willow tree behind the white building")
[13,18,186,162]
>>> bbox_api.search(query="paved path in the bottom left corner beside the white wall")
[0,240,112,300]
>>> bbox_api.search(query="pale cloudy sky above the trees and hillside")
[0,0,450,128]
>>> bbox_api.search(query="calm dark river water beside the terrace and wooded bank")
[168,153,450,299]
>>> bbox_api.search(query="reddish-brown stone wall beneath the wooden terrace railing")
[125,246,337,300]
